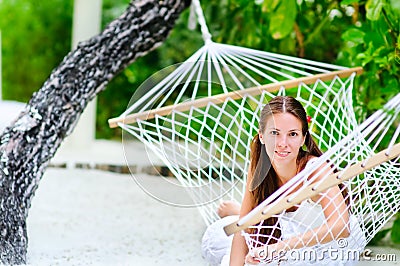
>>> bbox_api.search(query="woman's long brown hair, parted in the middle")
[250,96,322,244]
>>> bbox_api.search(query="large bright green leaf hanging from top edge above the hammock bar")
[269,0,297,39]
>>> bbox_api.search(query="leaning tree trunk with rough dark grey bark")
[0,0,190,264]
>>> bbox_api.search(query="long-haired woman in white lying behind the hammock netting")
[202,96,365,266]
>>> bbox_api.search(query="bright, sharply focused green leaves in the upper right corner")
[338,0,400,120]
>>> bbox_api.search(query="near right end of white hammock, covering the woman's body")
[225,93,400,262]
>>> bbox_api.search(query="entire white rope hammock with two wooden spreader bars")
[109,1,400,264]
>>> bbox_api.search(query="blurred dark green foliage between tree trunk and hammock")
[96,0,202,139]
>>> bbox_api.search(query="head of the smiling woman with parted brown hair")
[251,96,322,185]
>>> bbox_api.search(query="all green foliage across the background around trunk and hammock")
[0,0,400,138]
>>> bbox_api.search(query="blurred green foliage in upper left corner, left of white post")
[0,0,73,102]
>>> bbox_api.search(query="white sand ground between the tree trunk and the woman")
[28,169,206,265]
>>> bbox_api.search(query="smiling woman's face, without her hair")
[259,113,305,164]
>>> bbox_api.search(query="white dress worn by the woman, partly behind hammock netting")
[202,159,366,266]
